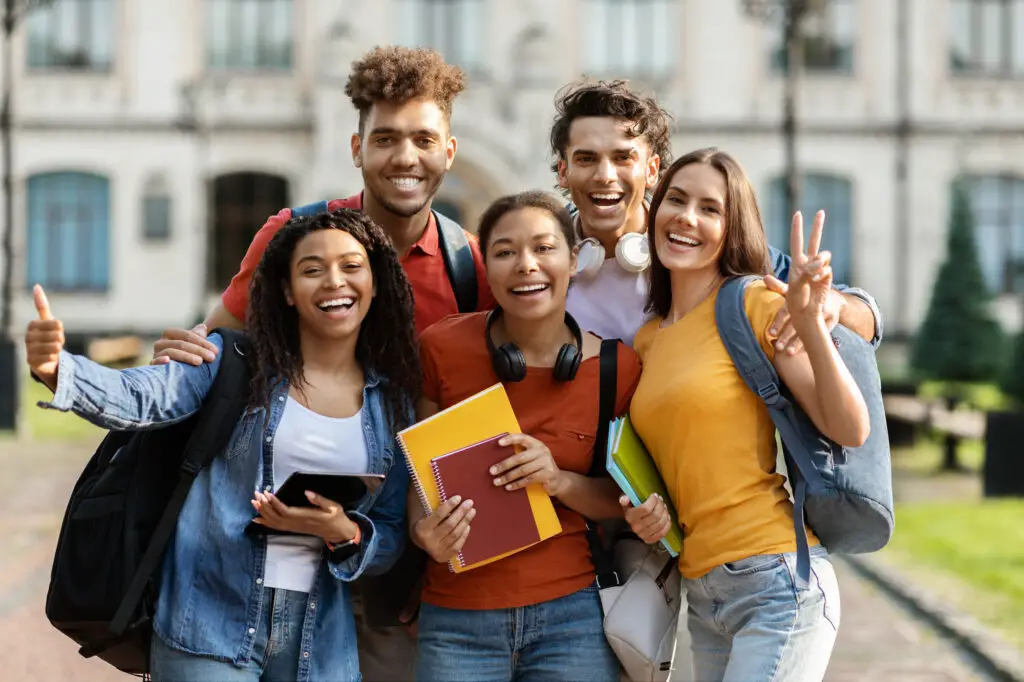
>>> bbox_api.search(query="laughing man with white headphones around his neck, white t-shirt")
[551,76,882,352]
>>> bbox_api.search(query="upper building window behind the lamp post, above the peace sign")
[771,0,857,74]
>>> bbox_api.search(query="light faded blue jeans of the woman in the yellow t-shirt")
[684,546,840,682]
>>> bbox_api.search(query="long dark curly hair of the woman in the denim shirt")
[246,209,422,430]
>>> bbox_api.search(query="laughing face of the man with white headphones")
[558,116,659,239]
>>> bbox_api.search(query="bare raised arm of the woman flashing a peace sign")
[773,211,870,446]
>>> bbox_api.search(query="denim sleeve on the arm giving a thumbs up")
[39,334,223,431]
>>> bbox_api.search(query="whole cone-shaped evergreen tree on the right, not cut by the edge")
[910,180,1006,470]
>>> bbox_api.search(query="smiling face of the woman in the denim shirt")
[285,229,374,339]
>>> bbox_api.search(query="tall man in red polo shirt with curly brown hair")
[154,47,494,681]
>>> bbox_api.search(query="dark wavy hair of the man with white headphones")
[551,80,672,172]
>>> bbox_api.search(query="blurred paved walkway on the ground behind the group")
[0,440,984,682]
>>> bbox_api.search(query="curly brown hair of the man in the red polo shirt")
[345,45,466,135]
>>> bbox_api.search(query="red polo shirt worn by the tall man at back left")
[220,194,495,332]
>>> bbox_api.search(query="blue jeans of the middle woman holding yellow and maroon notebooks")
[416,587,618,682]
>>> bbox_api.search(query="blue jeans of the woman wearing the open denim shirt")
[150,588,308,682]
